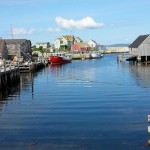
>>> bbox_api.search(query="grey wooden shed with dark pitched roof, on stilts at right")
[129,34,150,62]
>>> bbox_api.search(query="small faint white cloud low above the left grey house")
[12,28,35,35]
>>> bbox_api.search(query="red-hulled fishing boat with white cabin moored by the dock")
[49,53,72,64]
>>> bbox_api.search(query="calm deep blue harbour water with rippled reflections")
[0,54,150,150]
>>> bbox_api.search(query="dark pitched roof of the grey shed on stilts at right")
[129,34,150,48]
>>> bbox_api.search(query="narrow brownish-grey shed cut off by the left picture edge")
[0,40,8,59]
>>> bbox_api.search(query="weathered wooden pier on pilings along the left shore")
[0,59,48,89]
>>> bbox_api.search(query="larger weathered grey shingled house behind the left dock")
[5,39,32,60]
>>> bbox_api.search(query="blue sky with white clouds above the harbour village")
[0,0,150,45]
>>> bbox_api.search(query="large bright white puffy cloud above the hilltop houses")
[55,16,104,29]
